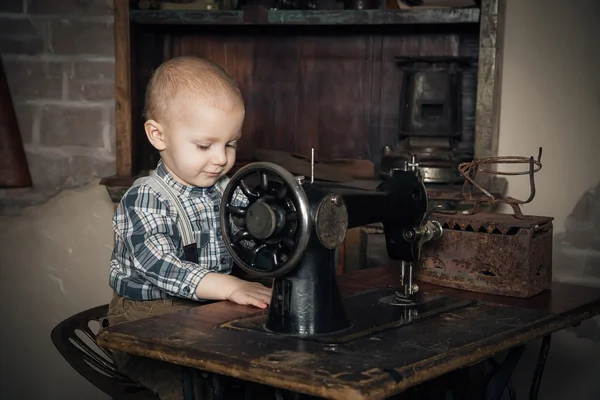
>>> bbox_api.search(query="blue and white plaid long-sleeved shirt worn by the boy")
[110,161,247,300]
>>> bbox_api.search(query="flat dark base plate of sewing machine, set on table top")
[218,287,476,344]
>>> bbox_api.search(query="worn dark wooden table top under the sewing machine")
[98,266,600,400]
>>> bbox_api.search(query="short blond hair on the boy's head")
[144,56,244,123]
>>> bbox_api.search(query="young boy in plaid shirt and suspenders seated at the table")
[107,57,271,400]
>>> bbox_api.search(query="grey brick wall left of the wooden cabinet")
[0,0,115,209]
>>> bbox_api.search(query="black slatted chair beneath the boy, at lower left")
[50,304,158,400]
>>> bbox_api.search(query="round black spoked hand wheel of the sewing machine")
[221,162,311,278]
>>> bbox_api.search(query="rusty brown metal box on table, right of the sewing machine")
[415,212,553,298]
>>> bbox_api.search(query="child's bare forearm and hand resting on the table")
[196,272,272,308]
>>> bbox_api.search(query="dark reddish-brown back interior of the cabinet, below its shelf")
[129,25,478,172]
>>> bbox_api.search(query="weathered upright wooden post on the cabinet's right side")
[475,0,504,158]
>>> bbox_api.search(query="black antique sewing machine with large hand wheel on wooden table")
[220,158,472,343]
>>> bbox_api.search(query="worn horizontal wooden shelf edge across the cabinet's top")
[129,8,480,25]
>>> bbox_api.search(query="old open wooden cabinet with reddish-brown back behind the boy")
[102,0,502,200]
